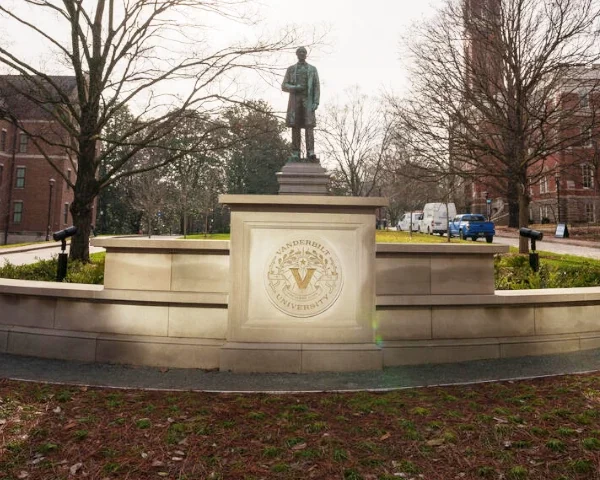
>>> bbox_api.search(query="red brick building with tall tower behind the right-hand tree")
[464,0,600,224]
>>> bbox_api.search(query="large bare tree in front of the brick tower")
[396,0,600,251]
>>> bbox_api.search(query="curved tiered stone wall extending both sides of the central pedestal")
[0,239,600,369]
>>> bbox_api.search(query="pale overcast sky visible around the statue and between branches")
[0,0,442,111]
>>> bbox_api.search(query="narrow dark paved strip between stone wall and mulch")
[0,349,600,392]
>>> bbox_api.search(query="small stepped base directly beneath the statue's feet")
[277,162,329,195]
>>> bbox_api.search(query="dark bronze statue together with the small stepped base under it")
[277,47,329,195]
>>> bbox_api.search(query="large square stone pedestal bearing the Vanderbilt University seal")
[219,195,387,372]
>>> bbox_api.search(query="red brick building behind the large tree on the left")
[0,75,77,244]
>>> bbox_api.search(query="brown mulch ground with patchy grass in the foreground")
[0,374,600,480]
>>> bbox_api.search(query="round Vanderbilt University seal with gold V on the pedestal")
[265,237,342,317]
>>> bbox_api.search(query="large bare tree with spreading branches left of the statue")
[0,0,310,261]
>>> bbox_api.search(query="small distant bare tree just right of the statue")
[319,88,391,197]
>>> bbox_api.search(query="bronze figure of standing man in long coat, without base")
[281,47,321,162]
